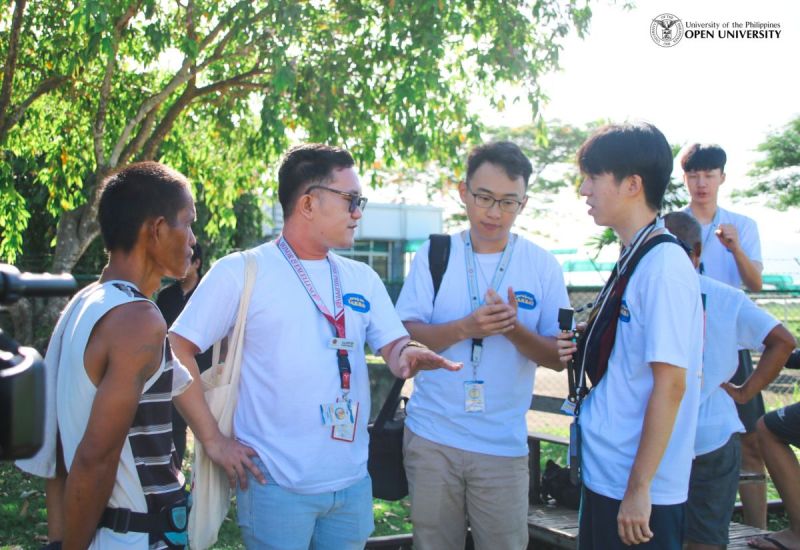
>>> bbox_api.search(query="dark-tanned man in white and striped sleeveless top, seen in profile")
[20,162,255,550]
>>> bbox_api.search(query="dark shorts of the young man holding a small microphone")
[578,487,686,550]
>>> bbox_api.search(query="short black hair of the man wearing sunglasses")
[278,143,355,218]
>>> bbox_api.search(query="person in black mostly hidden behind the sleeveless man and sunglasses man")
[156,243,211,466]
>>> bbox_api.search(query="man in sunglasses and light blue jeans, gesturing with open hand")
[170,144,460,550]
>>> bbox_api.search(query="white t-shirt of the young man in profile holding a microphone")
[580,243,703,505]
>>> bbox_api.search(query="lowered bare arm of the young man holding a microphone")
[617,363,686,544]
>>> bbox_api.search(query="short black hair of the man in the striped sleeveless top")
[97,161,189,252]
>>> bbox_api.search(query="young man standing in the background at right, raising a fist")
[680,143,767,529]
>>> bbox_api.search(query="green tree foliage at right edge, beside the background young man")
[741,116,800,210]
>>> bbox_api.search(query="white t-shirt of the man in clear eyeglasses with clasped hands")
[397,233,569,456]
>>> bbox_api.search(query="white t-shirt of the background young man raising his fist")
[684,206,761,288]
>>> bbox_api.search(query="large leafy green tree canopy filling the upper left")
[0,0,591,271]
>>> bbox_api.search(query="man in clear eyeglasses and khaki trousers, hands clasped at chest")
[397,142,569,550]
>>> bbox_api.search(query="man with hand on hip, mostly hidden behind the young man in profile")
[664,212,796,550]
